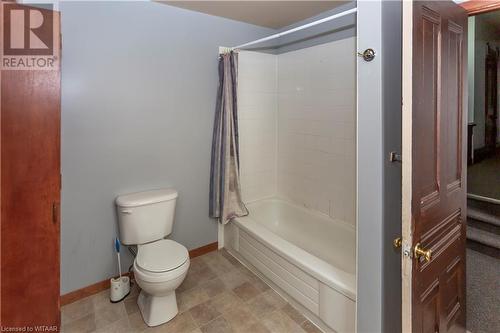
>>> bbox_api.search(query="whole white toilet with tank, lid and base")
[116,189,189,326]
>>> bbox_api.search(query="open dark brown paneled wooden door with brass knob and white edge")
[402,1,467,333]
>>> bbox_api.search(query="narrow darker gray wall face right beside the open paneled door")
[382,1,402,333]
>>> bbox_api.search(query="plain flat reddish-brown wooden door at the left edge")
[0,5,61,331]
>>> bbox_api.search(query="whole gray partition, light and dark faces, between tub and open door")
[356,1,401,333]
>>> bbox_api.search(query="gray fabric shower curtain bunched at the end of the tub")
[210,52,248,224]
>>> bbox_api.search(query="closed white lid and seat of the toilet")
[135,239,189,273]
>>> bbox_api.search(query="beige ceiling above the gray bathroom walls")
[160,1,348,29]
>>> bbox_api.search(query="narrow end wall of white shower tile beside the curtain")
[238,52,278,202]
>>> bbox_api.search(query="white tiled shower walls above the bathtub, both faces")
[238,37,356,226]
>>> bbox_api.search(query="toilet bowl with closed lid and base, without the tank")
[134,239,189,326]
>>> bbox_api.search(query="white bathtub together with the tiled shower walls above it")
[225,37,356,333]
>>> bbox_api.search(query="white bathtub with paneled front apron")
[224,198,356,332]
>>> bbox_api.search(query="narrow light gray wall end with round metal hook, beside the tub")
[356,1,385,333]
